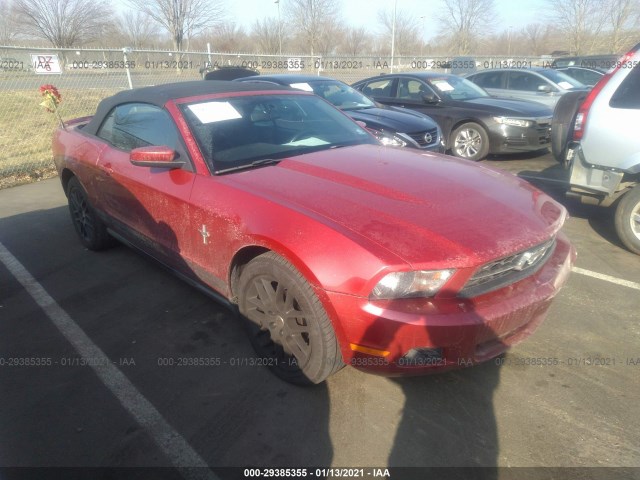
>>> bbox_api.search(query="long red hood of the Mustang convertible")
[225,145,565,268]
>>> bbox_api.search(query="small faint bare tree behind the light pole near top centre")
[378,10,422,56]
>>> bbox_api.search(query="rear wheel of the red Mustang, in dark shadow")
[67,177,113,251]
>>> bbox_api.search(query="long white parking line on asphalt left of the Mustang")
[0,243,218,480]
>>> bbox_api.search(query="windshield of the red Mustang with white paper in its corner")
[180,95,377,173]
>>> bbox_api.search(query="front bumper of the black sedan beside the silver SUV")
[489,122,551,153]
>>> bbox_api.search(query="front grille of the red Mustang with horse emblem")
[459,238,556,298]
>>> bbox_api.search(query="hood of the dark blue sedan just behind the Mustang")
[344,107,437,133]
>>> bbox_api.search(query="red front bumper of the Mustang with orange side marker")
[329,234,576,375]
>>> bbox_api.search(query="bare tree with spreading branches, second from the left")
[127,0,224,52]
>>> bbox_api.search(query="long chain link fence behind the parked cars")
[0,46,548,188]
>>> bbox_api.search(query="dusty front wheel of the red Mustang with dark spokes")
[238,252,344,385]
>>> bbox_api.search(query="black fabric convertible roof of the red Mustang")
[83,80,291,135]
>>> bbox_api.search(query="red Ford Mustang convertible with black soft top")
[53,81,575,384]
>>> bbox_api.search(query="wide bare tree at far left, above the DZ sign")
[15,0,111,48]
